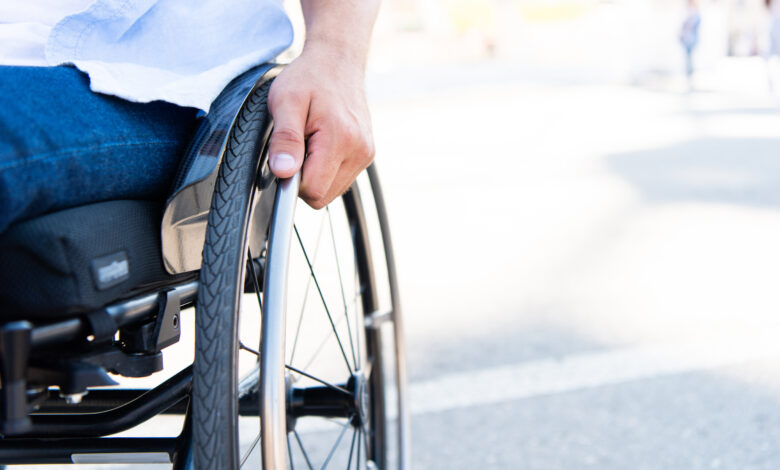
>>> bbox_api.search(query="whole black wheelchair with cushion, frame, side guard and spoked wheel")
[0,64,408,470]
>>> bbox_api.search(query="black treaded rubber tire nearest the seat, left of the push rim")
[192,82,270,470]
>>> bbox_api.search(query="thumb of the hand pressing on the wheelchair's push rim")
[268,92,309,178]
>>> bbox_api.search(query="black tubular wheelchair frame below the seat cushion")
[0,282,197,468]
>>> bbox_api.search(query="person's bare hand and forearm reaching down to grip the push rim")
[268,0,376,209]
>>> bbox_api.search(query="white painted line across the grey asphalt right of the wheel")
[410,338,780,414]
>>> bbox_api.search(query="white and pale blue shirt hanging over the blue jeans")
[0,0,293,110]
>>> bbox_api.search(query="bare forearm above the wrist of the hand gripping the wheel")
[301,0,379,71]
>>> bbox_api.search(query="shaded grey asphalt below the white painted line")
[412,363,780,470]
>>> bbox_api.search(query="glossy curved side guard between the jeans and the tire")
[161,64,282,274]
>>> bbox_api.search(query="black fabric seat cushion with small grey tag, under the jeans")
[0,201,193,321]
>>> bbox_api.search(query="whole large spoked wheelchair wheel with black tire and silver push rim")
[192,79,408,469]
